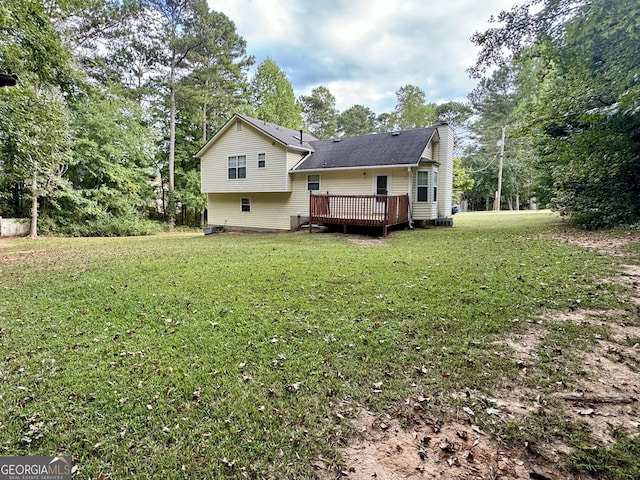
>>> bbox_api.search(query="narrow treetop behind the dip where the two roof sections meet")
[299,86,338,139]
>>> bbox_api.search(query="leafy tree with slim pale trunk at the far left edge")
[0,0,76,236]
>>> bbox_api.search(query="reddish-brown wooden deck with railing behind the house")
[309,193,409,236]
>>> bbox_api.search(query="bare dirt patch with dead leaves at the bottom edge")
[317,413,569,480]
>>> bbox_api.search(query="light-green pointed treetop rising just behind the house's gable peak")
[250,58,302,130]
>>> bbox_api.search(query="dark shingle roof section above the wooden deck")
[295,127,437,171]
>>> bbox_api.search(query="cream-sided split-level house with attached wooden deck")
[196,114,453,233]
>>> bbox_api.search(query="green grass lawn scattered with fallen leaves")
[0,213,640,479]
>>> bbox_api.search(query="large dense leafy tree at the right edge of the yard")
[471,0,640,228]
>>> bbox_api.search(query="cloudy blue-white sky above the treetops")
[208,0,523,114]
